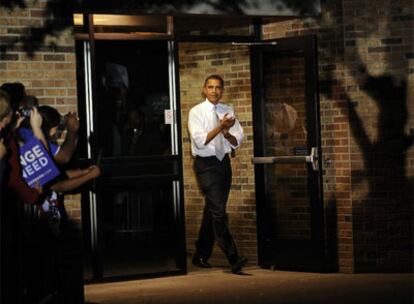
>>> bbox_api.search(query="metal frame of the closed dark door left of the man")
[77,14,187,283]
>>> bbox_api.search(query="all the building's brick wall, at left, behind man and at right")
[0,0,414,272]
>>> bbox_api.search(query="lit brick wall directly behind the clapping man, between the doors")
[179,43,257,265]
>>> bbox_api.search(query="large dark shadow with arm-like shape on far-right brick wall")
[346,68,414,271]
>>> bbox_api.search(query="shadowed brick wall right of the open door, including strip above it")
[263,0,414,272]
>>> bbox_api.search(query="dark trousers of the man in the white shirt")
[194,155,237,264]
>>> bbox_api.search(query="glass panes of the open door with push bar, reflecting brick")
[263,53,311,240]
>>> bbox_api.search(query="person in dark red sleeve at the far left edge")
[0,90,44,303]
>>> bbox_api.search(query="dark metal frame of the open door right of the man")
[250,36,325,271]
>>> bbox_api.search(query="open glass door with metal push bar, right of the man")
[251,37,324,271]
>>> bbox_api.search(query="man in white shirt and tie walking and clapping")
[188,75,247,273]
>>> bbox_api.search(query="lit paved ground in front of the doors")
[85,267,414,304]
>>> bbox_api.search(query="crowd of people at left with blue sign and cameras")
[0,83,100,303]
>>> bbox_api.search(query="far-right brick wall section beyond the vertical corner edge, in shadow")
[343,0,414,271]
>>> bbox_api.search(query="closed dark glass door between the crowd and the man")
[77,40,185,280]
